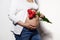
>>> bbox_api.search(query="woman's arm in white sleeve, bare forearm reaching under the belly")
[8,0,35,29]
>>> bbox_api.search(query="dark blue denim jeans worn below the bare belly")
[14,28,41,40]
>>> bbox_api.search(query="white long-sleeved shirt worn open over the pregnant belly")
[8,0,38,35]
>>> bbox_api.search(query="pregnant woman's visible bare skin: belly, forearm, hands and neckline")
[17,0,44,30]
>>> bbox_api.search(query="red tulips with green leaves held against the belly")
[27,9,51,23]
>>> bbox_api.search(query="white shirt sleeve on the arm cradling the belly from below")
[8,0,20,23]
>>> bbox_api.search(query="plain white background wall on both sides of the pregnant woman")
[0,0,60,40]
